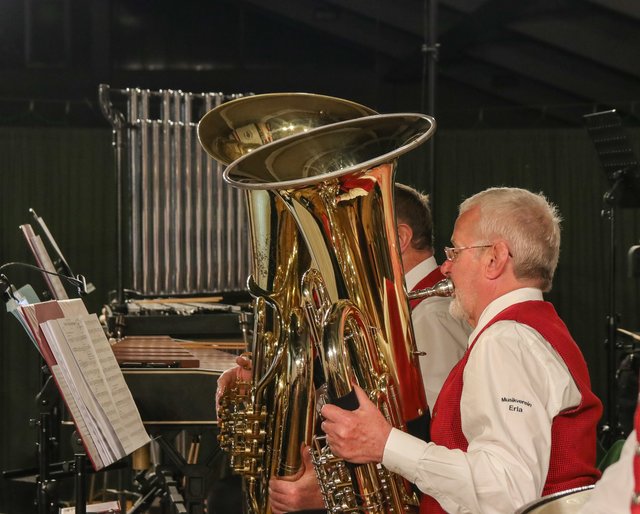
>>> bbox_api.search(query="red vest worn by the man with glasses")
[420,301,602,514]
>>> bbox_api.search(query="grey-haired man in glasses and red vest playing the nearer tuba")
[322,188,602,514]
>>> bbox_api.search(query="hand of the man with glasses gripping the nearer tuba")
[321,384,392,464]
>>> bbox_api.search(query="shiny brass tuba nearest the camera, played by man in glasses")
[224,110,435,514]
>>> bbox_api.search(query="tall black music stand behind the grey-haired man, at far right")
[583,109,640,440]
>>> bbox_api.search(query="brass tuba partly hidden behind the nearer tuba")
[198,93,375,514]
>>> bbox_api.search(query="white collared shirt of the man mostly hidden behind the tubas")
[405,257,471,409]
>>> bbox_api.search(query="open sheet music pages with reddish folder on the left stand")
[19,299,150,470]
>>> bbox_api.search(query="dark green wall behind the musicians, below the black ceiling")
[0,119,640,513]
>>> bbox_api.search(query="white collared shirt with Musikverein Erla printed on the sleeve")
[382,288,581,514]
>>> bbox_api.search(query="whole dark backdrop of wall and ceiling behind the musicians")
[0,0,640,514]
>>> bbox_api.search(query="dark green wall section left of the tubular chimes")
[0,127,115,514]
